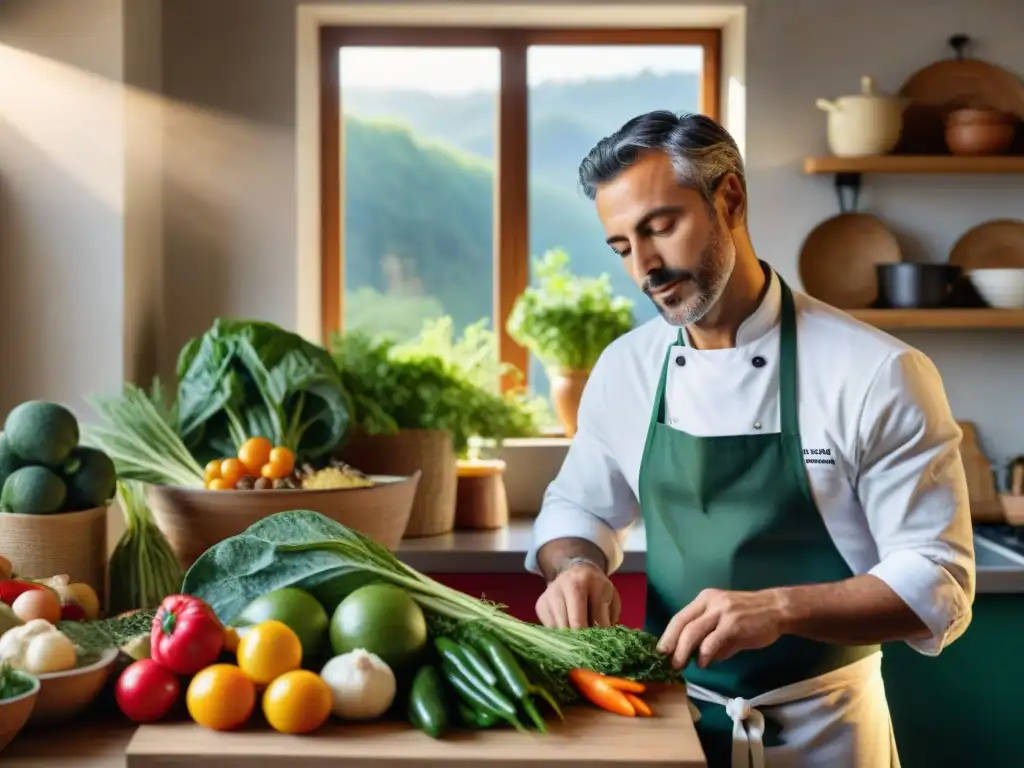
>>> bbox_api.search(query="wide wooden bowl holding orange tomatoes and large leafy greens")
[146,472,420,568]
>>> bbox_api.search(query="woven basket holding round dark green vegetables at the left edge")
[0,507,108,604]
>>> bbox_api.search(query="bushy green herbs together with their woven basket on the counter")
[331,317,538,538]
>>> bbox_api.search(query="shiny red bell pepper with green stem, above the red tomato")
[150,595,224,675]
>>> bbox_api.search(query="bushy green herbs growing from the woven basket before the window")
[332,317,544,454]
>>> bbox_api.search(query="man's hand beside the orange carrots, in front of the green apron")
[657,590,784,670]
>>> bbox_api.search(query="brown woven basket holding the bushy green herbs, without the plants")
[339,429,458,539]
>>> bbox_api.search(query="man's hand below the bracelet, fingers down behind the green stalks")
[537,563,621,630]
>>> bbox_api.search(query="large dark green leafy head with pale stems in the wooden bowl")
[178,318,350,463]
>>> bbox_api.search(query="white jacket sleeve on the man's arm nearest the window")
[526,350,640,573]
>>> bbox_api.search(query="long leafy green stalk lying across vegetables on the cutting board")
[182,510,678,702]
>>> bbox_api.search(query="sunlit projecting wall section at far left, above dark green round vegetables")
[0,0,163,415]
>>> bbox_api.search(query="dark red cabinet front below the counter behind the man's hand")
[430,573,647,629]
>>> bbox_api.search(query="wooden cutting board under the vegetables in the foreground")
[127,686,707,768]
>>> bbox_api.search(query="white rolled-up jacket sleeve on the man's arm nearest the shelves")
[857,350,975,655]
